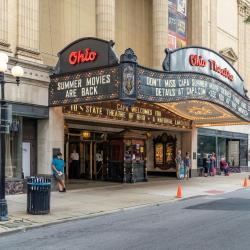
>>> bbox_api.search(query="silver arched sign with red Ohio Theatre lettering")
[163,46,245,95]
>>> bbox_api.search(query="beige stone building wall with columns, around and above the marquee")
[0,0,250,181]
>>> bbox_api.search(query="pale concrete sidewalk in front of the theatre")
[0,173,249,234]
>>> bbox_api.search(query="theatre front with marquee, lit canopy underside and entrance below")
[49,38,250,182]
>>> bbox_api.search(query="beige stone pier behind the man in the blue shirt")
[37,107,64,175]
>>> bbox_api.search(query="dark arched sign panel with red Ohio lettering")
[55,37,118,74]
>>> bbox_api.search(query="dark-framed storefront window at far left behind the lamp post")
[5,102,49,194]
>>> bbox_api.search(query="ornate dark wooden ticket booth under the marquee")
[107,131,147,183]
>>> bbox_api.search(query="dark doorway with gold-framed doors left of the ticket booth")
[64,131,107,180]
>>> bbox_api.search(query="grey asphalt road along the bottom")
[0,189,250,250]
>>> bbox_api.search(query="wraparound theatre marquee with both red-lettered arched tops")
[49,38,250,122]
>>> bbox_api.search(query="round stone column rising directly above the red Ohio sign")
[96,0,115,41]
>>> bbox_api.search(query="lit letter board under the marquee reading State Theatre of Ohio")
[63,101,192,129]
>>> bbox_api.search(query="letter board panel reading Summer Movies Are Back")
[49,66,120,106]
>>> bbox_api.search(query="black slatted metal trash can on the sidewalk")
[27,177,51,214]
